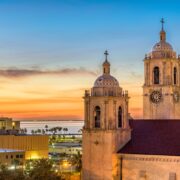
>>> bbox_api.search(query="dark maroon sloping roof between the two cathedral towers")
[118,120,180,156]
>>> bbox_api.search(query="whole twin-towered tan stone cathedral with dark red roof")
[82,19,180,180]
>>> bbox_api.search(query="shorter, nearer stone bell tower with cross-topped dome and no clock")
[82,51,131,180]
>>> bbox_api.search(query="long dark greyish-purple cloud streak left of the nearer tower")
[0,67,97,78]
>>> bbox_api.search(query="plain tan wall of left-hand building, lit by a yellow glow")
[0,135,48,159]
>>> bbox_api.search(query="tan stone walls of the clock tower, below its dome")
[143,59,180,119]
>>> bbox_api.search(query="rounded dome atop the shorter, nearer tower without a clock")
[94,74,119,87]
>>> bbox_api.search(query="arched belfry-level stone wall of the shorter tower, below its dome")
[85,96,129,129]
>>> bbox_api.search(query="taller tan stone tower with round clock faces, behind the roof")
[143,19,180,119]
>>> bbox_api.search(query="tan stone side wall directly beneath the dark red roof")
[122,154,180,180]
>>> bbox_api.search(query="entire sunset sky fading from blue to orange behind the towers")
[0,0,180,120]
